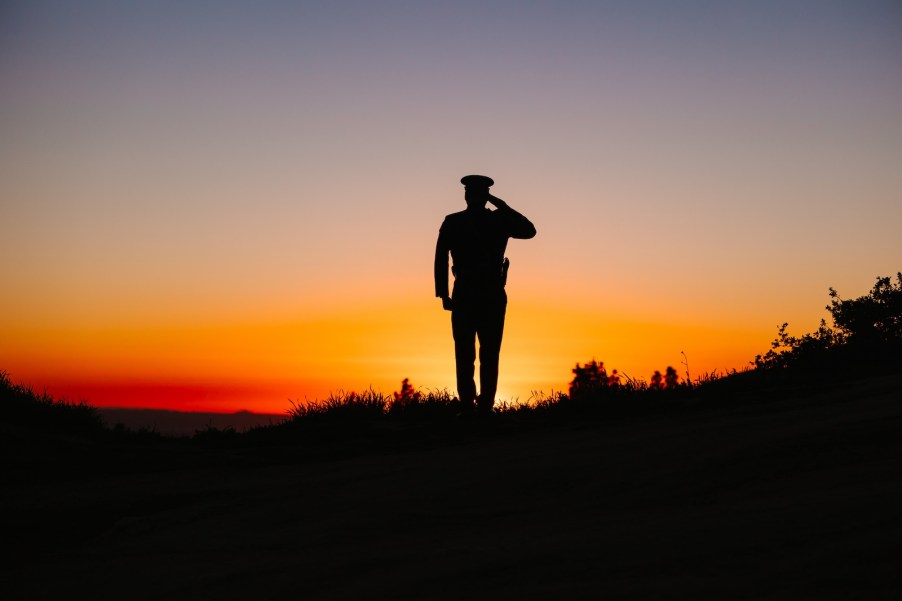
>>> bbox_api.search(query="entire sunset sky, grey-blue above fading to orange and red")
[0,0,902,412]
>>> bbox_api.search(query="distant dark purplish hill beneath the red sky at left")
[97,407,288,436]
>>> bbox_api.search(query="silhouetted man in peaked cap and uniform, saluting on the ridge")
[435,175,536,414]
